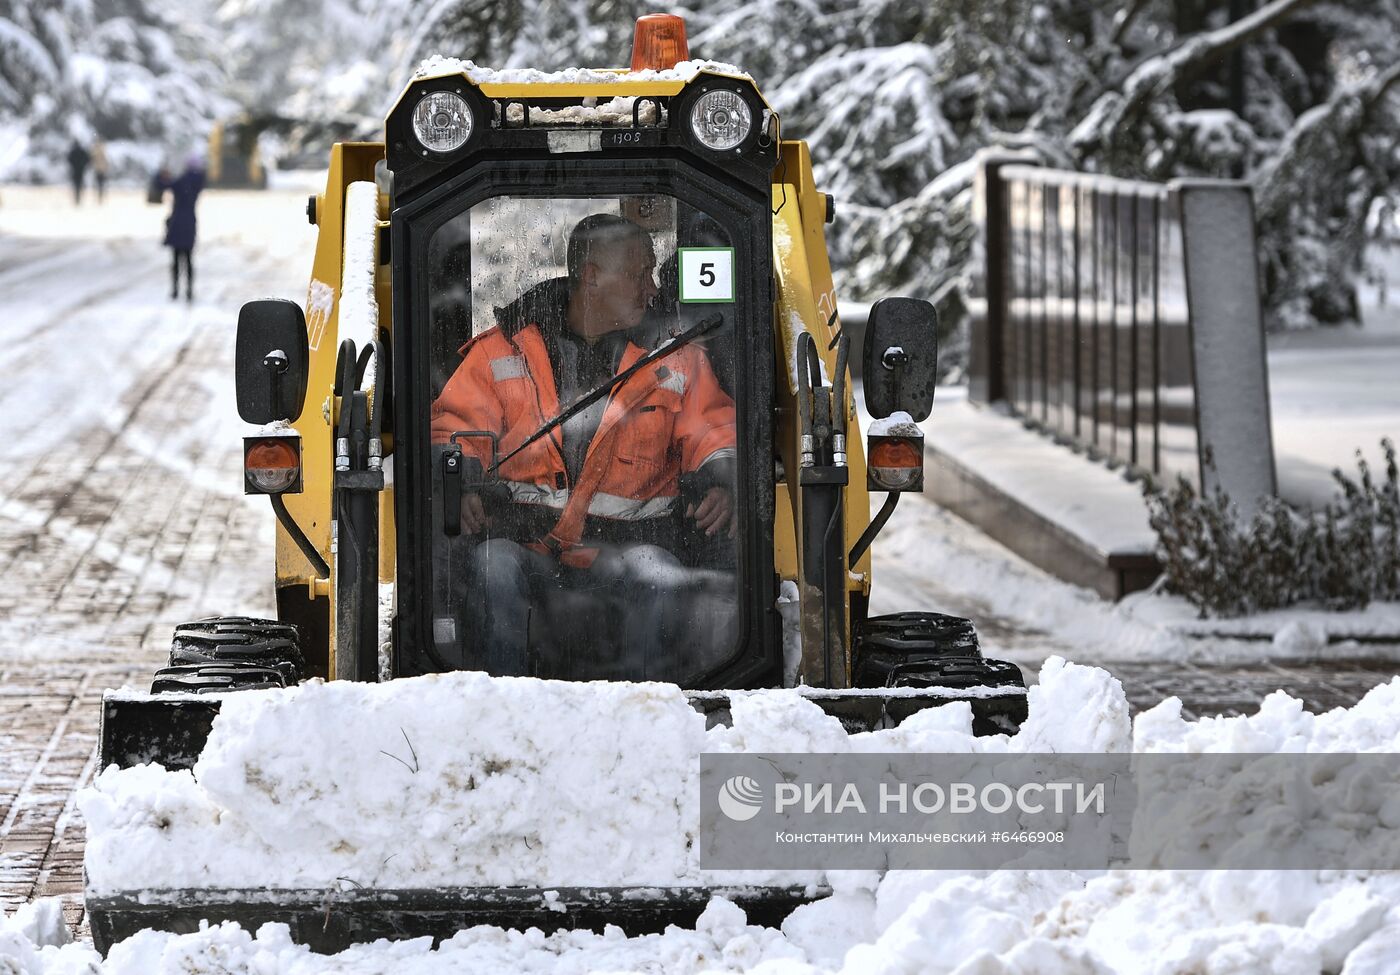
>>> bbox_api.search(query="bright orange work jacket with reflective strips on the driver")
[431,325,735,565]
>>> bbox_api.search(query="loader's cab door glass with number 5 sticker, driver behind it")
[427,195,741,685]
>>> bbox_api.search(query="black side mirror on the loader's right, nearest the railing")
[861,298,938,423]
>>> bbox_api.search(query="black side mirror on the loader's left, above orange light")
[234,298,309,423]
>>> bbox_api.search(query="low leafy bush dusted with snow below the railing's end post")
[1147,440,1400,616]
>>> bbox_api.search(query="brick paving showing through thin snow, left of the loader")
[0,308,270,922]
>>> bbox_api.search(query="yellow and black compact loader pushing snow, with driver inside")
[87,7,1026,948]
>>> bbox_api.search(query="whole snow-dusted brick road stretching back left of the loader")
[0,189,292,927]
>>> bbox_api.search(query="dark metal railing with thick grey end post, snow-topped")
[969,154,1274,499]
